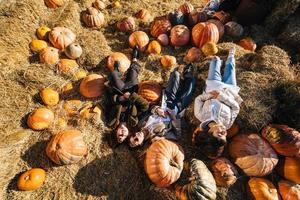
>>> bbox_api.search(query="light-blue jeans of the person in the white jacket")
[207,56,237,86]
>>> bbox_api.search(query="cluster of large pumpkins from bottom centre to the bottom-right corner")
[144,124,300,200]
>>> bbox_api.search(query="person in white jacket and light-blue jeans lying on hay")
[194,48,242,158]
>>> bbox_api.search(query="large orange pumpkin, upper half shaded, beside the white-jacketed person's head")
[229,133,278,177]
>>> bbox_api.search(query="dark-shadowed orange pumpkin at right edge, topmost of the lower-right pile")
[262,124,300,158]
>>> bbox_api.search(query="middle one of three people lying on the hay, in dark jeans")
[129,64,196,147]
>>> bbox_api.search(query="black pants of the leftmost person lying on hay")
[109,61,140,93]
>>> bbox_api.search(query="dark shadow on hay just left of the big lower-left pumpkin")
[21,140,58,170]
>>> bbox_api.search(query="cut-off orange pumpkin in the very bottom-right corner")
[278,180,300,200]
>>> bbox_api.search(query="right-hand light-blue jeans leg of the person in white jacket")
[223,56,237,86]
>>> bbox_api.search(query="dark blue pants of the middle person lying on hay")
[165,71,196,112]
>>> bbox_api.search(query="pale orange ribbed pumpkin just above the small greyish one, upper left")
[49,27,76,50]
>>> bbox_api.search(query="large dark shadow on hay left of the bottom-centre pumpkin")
[73,145,149,199]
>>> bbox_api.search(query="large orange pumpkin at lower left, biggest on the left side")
[46,130,88,165]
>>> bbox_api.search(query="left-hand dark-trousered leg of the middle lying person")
[165,70,180,109]
